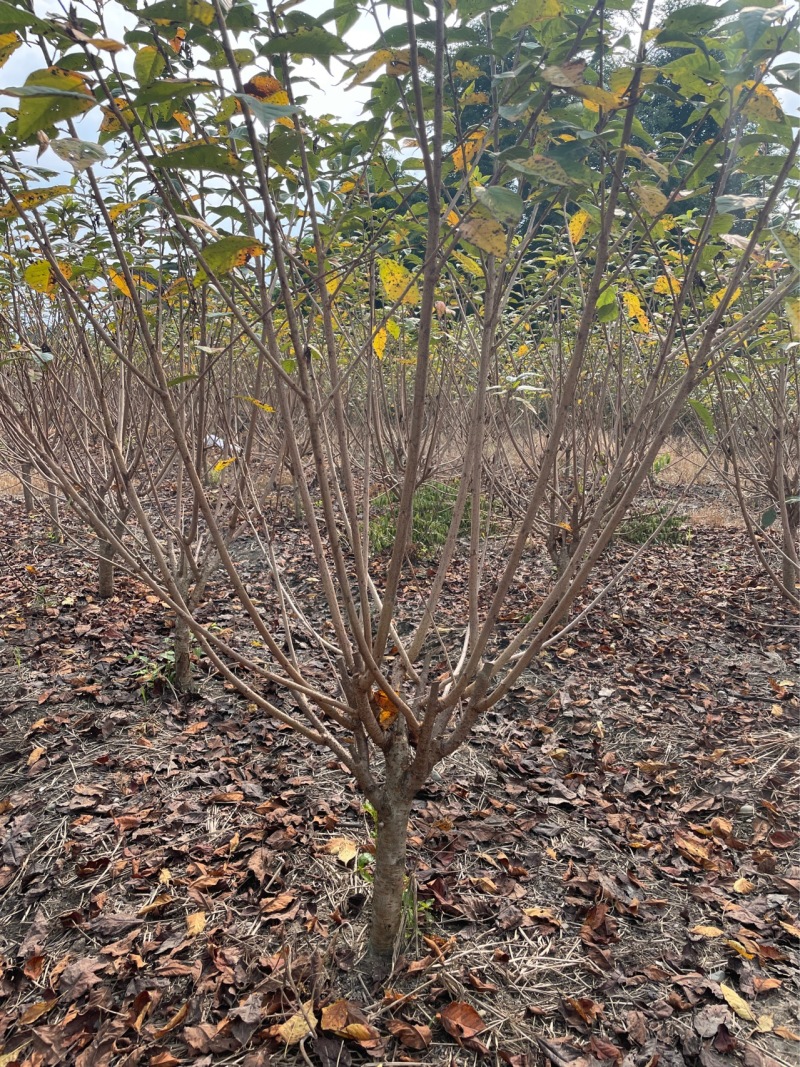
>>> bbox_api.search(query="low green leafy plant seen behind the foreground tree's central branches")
[369,481,489,558]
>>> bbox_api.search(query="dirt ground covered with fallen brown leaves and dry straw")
[0,498,800,1067]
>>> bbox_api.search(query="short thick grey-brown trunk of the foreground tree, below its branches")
[368,787,411,978]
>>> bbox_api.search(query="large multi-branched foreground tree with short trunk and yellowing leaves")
[0,0,798,972]
